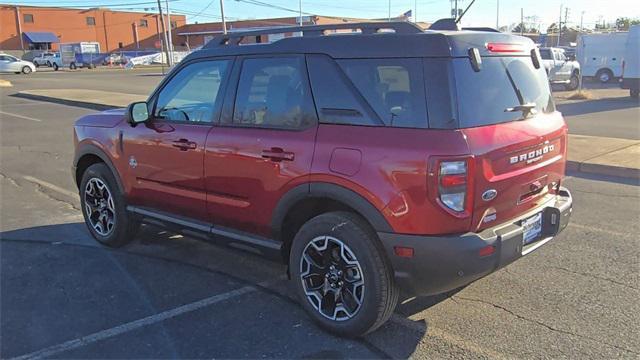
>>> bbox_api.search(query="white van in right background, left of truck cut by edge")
[576,32,627,83]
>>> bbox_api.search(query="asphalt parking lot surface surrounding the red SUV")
[0,69,640,359]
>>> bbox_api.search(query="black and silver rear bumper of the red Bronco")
[378,188,573,295]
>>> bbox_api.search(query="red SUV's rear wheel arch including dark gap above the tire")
[271,182,393,261]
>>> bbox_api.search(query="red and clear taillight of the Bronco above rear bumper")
[429,157,473,217]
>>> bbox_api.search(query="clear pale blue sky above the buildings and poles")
[6,0,640,29]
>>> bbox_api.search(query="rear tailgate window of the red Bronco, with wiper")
[453,57,555,128]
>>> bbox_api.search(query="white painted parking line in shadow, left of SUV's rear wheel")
[13,281,262,360]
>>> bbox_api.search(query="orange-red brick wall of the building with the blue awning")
[0,5,186,52]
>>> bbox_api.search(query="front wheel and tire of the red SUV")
[80,163,140,247]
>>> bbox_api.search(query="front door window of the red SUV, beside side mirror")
[155,60,230,122]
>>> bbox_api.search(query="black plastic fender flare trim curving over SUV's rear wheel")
[271,182,393,239]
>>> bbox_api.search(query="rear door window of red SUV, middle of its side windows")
[233,57,315,129]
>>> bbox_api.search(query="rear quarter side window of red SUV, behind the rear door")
[338,59,427,128]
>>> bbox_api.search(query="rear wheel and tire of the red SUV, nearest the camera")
[289,212,399,337]
